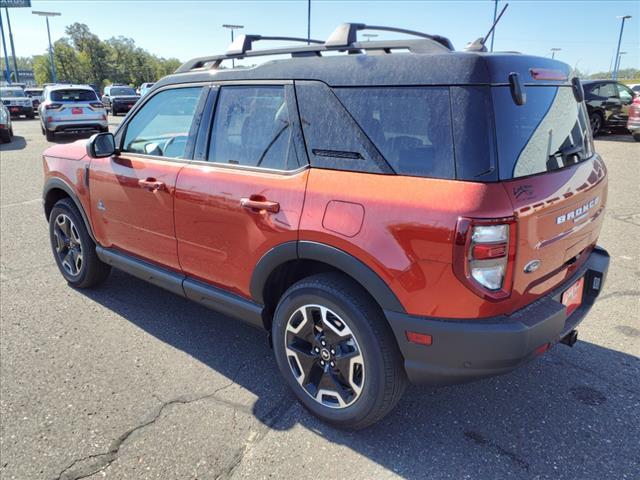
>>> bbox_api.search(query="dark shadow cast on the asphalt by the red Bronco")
[81,271,640,479]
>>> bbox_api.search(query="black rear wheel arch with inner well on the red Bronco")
[250,241,405,329]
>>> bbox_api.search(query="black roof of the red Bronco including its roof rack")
[154,24,570,90]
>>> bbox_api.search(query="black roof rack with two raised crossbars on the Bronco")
[175,23,454,73]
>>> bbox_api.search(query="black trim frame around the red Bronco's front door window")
[114,82,211,163]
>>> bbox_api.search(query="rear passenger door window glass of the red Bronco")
[207,86,298,170]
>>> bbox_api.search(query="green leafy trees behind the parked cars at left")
[18,23,181,88]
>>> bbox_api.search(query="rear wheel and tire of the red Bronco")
[272,274,407,430]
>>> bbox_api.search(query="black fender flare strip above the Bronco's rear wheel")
[250,240,406,313]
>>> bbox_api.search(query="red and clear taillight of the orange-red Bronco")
[453,217,516,300]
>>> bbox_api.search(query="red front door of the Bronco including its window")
[89,85,206,270]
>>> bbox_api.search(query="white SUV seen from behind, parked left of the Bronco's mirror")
[39,85,109,141]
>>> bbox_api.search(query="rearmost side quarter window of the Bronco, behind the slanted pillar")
[334,87,455,178]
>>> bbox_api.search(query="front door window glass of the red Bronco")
[122,87,203,158]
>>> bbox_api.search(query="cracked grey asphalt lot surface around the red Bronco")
[0,119,640,480]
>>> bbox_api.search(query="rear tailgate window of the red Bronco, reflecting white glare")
[493,87,593,180]
